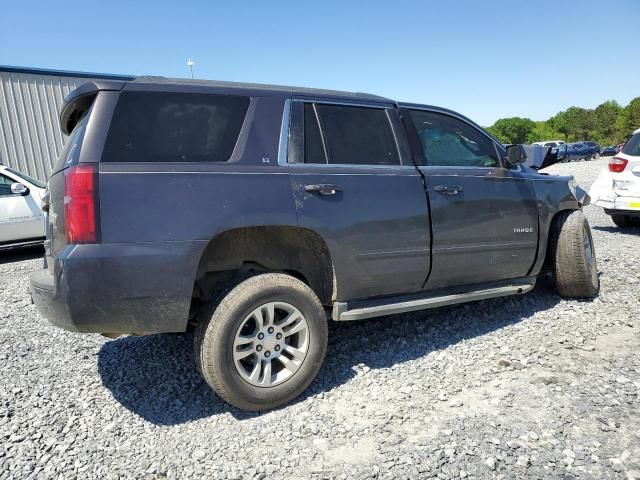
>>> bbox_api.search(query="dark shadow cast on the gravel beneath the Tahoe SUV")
[98,278,560,425]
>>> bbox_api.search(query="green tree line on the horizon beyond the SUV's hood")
[487,97,640,145]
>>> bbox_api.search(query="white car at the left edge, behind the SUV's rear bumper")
[0,165,46,250]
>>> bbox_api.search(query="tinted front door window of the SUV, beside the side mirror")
[411,110,500,167]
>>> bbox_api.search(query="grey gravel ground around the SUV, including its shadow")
[0,160,640,479]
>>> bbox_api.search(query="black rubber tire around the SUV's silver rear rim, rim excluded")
[194,273,328,410]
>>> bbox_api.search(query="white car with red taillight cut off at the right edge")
[589,129,640,227]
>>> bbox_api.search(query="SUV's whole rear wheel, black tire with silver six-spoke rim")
[194,273,328,410]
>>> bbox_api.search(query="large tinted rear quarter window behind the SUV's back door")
[102,92,249,162]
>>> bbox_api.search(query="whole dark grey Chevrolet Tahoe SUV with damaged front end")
[31,78,599,410]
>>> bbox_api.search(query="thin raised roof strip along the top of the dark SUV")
[127,76,393,102]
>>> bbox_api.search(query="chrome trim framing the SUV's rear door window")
[278,97,415,170]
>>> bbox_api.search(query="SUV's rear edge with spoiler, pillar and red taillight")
[42,81,124,274]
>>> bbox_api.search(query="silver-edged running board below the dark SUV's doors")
[332,277,536,321]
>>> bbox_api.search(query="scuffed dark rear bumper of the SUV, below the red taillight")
[30,242,206,335]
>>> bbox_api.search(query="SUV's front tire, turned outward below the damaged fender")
[550,210,600,298]
